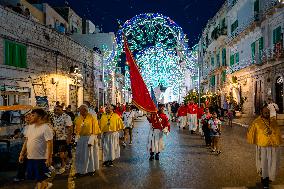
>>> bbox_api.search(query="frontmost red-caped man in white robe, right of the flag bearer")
[187,100,198,134]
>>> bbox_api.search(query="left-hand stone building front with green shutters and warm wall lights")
[0,6,96,108]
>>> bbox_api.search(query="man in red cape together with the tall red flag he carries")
[123,35,170,160]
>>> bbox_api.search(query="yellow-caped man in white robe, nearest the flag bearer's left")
[99,105,124,167]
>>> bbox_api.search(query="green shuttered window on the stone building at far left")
[5,40,27,68]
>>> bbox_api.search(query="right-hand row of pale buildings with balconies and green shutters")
[199,0,284,115]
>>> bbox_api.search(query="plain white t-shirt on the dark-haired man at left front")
[25,124,53,159]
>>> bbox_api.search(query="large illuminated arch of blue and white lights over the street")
[116,13,197,100]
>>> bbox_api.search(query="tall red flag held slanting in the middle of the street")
[123,36,157,113]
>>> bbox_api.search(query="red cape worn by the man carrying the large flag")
[147,113,170,131]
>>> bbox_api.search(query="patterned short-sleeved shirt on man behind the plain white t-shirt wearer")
[53,113,73,140]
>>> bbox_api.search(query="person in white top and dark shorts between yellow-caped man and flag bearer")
[122,105,135,147]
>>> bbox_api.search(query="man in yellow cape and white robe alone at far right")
[247,106,282,189]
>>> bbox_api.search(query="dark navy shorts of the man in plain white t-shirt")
[27,159,49,182]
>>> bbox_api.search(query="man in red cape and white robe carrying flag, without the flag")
[147,104,170,161]
